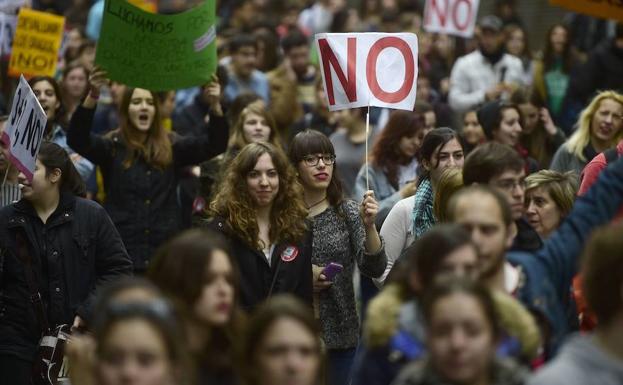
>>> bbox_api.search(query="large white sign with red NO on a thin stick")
[316,33,418,111]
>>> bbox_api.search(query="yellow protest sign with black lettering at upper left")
[9,8,65,76]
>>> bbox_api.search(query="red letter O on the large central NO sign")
[366,36,415,103]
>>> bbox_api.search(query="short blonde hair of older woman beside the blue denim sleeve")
[526,170,578,217]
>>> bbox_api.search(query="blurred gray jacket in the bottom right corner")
[528,335,623,385]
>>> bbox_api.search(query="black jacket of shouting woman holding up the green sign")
[67,106,229,272]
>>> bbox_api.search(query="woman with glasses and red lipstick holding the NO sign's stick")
[289,130,386,385]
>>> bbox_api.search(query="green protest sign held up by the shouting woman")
[95,0,217,91]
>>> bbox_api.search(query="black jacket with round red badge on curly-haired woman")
[207,218,313,311]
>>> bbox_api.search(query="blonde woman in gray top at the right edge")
[550,91,623,175]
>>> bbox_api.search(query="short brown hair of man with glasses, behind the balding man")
[463,142,525,186]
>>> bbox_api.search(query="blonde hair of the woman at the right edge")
[565,91,623,161]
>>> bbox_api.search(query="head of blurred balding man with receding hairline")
[448,185,515,279]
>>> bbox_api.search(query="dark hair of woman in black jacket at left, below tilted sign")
[37,142,86,198]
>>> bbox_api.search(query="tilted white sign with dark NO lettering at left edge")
[2,76,47,181]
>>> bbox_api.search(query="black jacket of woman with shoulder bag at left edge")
[0,194,132,360]
